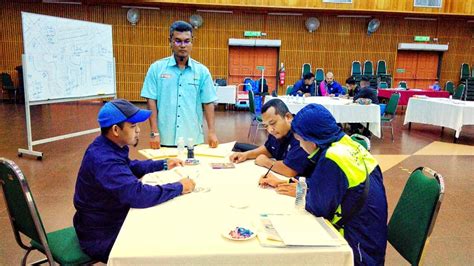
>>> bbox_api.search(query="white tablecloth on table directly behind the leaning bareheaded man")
[265,96,381,138]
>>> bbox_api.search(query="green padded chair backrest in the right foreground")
[388,167,444,265]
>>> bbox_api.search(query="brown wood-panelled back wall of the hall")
[0,1,474,101]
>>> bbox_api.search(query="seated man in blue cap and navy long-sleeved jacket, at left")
[74,99,195,262]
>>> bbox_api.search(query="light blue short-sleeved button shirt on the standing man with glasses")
[141,56,217,145]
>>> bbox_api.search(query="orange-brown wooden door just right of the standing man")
[228,46,278,93]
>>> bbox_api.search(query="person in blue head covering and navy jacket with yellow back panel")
[260,104,387,265]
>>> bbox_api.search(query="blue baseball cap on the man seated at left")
[97,99,151,128]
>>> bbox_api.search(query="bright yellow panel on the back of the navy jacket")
[326,135,378,235]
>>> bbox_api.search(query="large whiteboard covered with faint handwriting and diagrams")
[21,12,116,102]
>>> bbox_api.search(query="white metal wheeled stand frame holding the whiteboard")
[18,55,117,160]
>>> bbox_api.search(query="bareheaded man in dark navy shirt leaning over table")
[230,99,314,195]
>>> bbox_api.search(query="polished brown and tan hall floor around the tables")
[0,102,474,265]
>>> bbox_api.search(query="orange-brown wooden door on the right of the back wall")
[394,51,440,89]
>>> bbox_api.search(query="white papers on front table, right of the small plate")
[270,214,341,246]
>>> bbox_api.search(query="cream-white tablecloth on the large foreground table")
[108,154,353,265]
